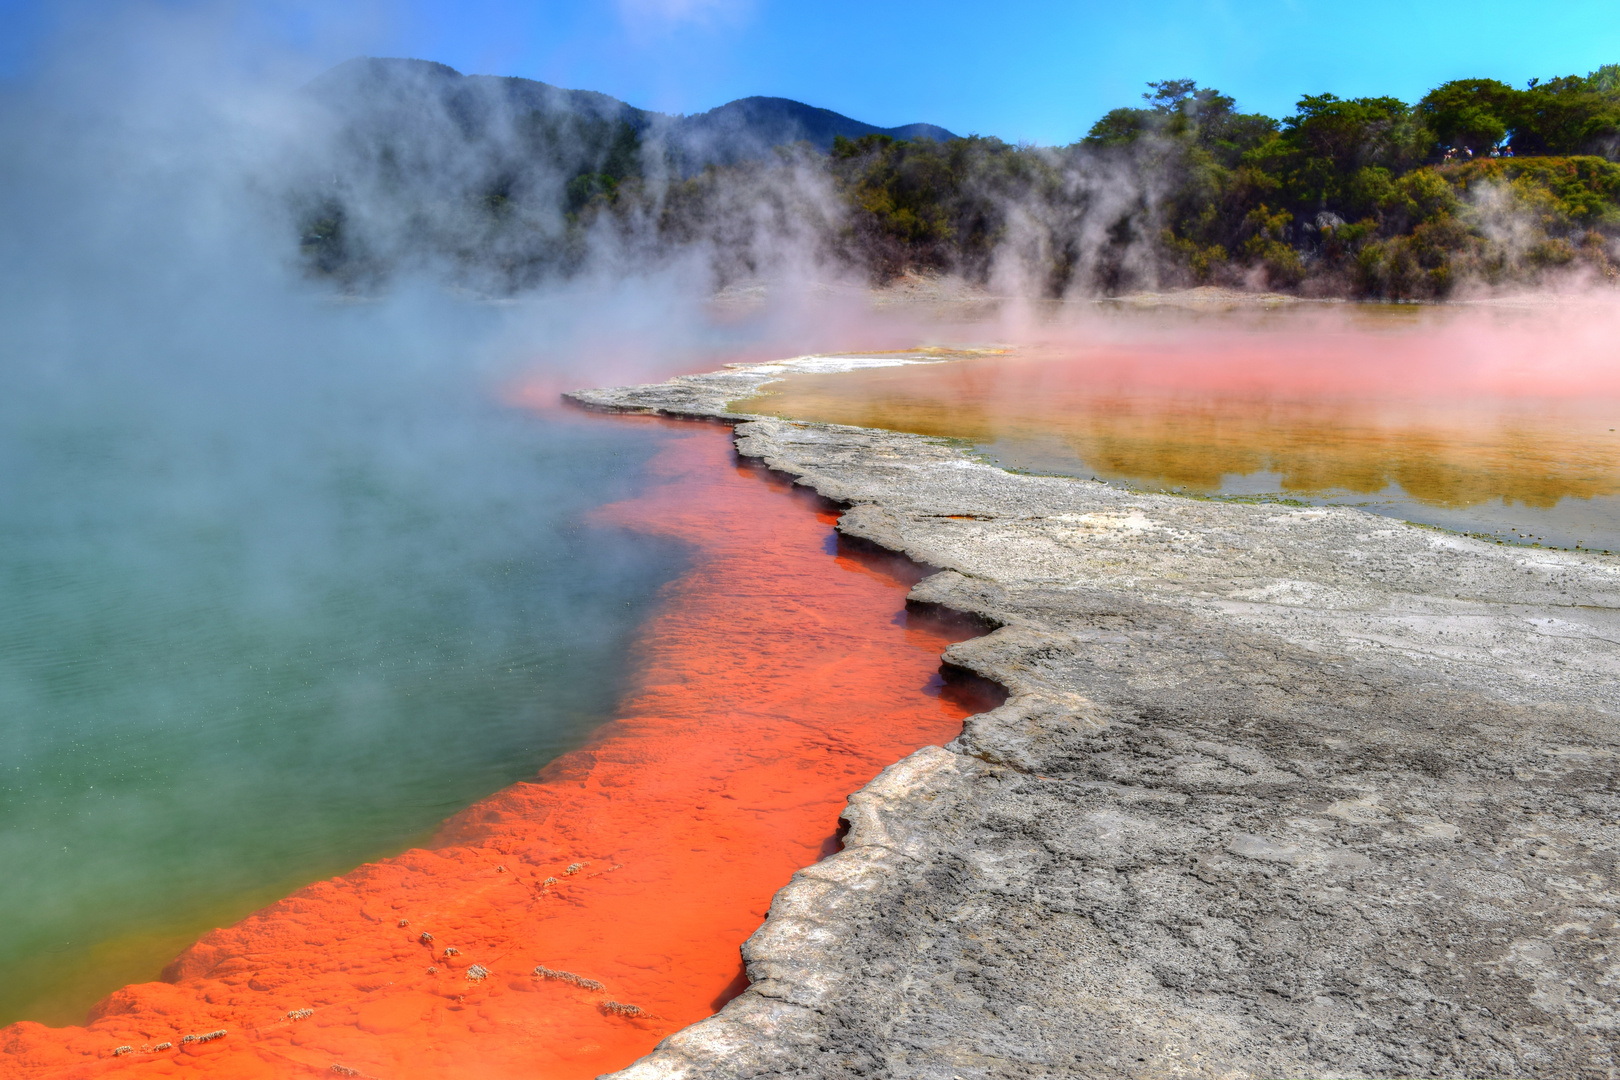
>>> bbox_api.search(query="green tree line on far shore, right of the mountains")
[803,65,1620,298]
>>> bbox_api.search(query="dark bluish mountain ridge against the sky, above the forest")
[305,57,956,172]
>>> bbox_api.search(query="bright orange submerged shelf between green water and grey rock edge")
[0,419,972,1080]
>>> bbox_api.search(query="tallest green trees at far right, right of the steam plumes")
[1081,72,1620,298]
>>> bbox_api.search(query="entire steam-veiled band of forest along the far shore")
[303,65,1620,300]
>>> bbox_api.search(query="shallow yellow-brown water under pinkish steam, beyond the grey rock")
[735,311,1620,551]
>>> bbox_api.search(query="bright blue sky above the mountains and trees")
[9,0,1620,142]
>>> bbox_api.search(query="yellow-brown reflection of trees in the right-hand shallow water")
[745,382,1620,510]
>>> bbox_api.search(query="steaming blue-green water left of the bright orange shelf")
[0,299,682,1023]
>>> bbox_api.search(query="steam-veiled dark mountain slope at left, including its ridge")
[287,57,956,283]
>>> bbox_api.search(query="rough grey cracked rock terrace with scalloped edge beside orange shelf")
[575,368,1620,1080]
